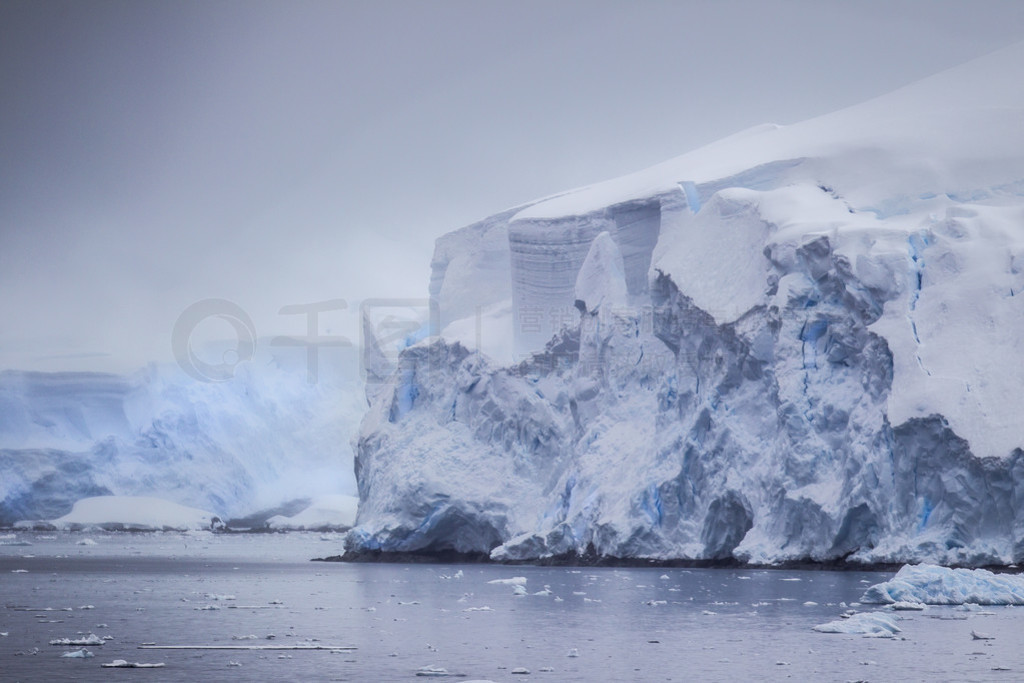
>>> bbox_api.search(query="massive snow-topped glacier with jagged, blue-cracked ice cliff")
[348,44,1024,565]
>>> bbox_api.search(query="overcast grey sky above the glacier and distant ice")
[6,0,1024,371]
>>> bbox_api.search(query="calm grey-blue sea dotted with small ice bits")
[0,532,1024,682]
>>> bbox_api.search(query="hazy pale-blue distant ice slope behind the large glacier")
[0,349,366,524]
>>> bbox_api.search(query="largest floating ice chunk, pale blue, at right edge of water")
[860,564,1024,605]
